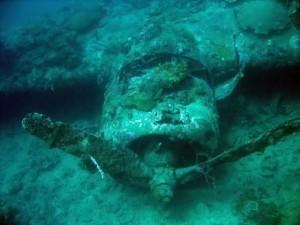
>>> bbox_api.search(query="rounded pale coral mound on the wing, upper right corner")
[235,0,290,35]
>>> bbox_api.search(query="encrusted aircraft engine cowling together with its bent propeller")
[22,55,300,204]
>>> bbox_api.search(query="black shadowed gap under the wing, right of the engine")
[218,66,300,146]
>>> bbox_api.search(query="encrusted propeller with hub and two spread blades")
[22,113,300,203]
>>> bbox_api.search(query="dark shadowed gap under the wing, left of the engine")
[0,82,104,123]
